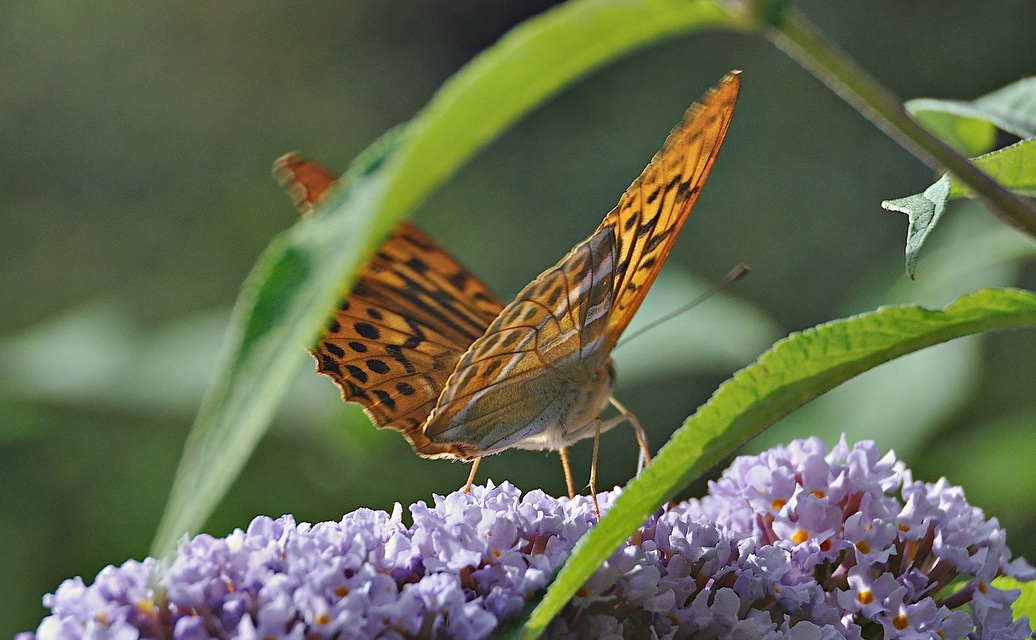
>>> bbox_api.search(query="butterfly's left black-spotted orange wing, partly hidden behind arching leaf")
[275,155,503,457]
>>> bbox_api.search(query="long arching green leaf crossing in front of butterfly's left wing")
[152,0,747,555]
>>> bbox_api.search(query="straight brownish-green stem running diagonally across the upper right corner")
[767,8,1036,237]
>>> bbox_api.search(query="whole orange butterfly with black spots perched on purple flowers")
[274,71,741,507]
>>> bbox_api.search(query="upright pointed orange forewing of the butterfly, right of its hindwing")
[600,72,741,351]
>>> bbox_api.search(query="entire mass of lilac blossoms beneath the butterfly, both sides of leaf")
[18,439,1034,640]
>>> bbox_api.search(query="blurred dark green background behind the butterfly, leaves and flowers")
[0,0,1036,637]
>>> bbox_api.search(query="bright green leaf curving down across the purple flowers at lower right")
[523,289,1036,638]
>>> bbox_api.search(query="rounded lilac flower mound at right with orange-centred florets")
[688,438,1036,638]
